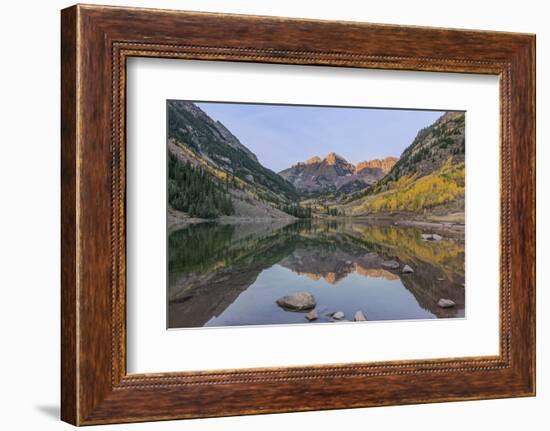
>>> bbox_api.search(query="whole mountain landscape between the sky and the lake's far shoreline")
[167,101,465,226]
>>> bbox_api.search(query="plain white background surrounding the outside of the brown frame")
[0,0,550,431]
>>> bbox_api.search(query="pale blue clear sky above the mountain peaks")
[196,102,444,172]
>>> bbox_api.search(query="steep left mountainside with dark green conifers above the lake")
[167,101,298,223]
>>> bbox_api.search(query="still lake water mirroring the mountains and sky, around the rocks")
[168,221,464,328]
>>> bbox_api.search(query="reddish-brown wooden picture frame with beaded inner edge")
[61,5,535,425]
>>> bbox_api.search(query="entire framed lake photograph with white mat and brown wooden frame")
[61,5,535,425]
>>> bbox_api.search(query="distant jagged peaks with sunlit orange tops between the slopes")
[279,153,397,192]
